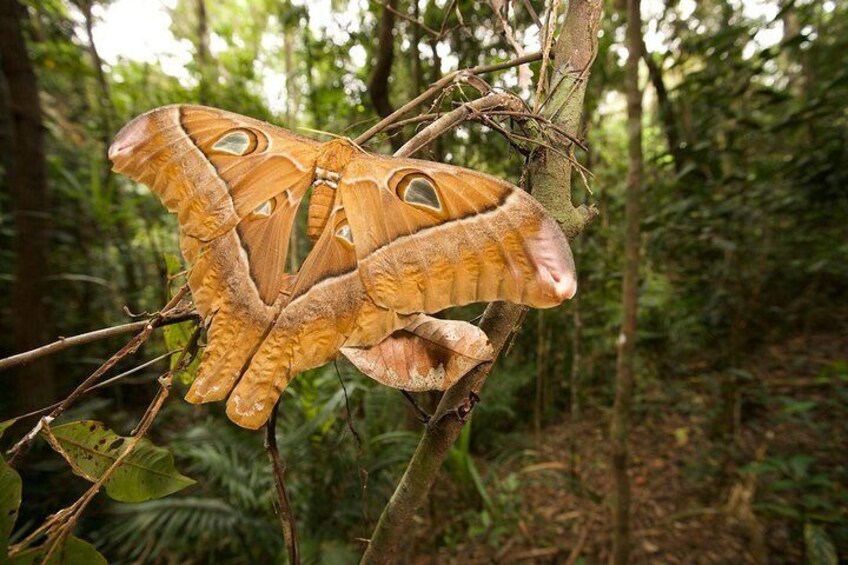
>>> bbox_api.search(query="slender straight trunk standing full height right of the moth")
[610,0,642,565]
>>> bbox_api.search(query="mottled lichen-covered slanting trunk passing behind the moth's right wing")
[362,0,602,563]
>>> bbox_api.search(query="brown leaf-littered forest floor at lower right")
[408,333,848,563]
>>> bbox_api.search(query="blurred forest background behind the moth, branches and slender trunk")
[0,0,848,563]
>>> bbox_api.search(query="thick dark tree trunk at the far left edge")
[0,0,54,411]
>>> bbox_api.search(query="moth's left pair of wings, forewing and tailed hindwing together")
[109,105,319,402]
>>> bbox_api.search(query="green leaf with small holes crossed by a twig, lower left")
[45,420,194,502]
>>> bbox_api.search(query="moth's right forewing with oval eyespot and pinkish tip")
[339,155,576,314]
